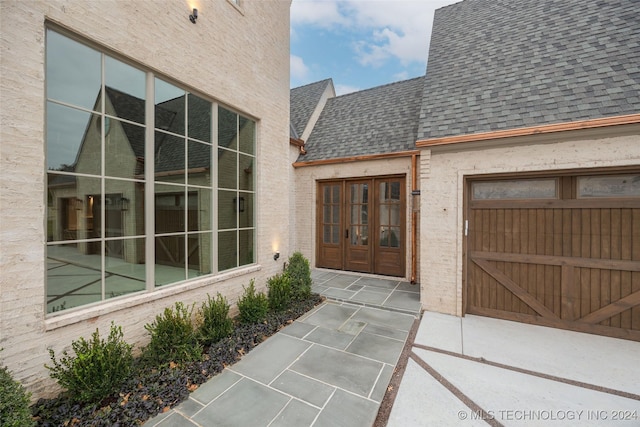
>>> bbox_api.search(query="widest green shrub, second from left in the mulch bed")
[45,322,133,403]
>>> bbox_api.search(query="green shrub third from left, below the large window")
[142,301,202,366]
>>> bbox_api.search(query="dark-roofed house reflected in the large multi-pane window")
[48,87,255,284]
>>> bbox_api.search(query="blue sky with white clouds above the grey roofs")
[290,0,460,95]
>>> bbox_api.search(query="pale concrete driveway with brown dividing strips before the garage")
[387,312,640,427]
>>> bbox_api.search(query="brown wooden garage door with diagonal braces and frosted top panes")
[465,170,640,341]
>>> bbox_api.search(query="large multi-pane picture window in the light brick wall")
[46,29,256,313]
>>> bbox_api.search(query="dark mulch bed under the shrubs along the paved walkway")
[31,294,324,427]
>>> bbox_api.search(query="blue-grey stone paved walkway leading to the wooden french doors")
[146,270,419,427]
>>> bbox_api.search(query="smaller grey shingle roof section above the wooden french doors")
[300,77,424,162]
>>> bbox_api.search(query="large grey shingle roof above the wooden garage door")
[418,0,640,139]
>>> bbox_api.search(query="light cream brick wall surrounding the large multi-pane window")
[0,0,291,397]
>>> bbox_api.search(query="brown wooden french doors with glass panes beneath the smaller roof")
[317,177,406,276]
